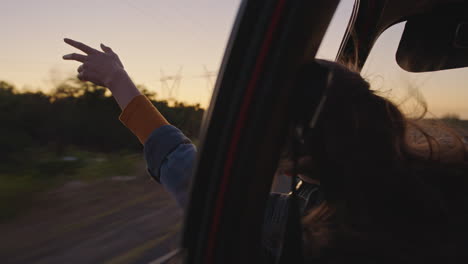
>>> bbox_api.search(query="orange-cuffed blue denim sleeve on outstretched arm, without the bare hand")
[120,95,196,208]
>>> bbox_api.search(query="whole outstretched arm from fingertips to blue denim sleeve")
[63,38,196,207]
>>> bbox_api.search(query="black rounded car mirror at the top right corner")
[396,4,468,72]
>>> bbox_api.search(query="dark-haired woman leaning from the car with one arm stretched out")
[63,39,468,263]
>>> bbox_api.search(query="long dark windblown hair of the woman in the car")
[298,60,468,263]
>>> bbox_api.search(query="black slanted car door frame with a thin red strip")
[182,0,339,263]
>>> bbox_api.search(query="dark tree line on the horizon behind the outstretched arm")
[0,79,204,167]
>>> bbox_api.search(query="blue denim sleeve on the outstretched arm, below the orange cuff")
[144,125,197,208]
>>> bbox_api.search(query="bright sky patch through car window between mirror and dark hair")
[362,22,468,126]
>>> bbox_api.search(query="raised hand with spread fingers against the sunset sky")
[63,38,126,90]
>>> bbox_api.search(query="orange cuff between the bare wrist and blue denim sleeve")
[119,95,169,144]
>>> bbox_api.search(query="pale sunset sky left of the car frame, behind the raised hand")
[0,0,240,105]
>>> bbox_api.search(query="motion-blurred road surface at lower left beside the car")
[0,165,183,264]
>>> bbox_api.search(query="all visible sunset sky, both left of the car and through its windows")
[0,0,468,118]
